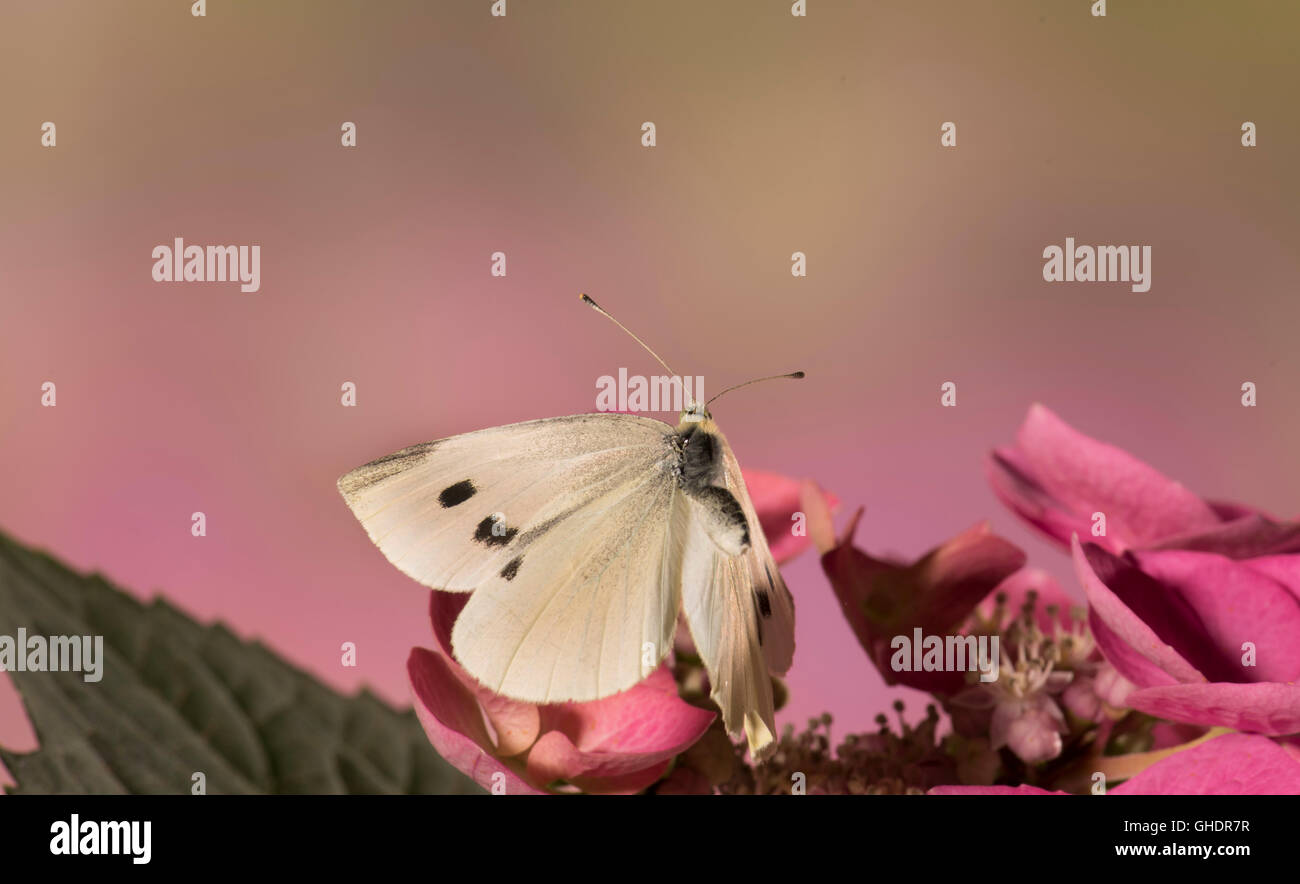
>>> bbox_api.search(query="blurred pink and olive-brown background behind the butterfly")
[0,0,1300,774]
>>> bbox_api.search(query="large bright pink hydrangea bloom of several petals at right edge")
[989,406,1300,735]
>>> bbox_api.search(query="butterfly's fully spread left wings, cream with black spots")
[339,415,686,703]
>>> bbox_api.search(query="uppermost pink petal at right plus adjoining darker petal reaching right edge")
[988,404,1300,559]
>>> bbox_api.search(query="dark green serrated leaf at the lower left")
[0,534,481,794]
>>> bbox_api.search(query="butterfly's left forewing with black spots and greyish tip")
[338,415,672,592]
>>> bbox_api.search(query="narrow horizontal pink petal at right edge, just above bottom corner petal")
[1126,681,1300,736]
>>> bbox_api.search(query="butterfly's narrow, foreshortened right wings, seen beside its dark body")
[679,426,794,758]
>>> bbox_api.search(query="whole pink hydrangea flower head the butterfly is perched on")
[410,406,1300,794]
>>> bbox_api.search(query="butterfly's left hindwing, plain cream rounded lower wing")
[451,468,686,703]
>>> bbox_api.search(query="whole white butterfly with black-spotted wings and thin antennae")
[338,295,803,758]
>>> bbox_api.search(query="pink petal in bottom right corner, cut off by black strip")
[1110,733,1300,796]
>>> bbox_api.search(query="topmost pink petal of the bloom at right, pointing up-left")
[989,404,1221,551]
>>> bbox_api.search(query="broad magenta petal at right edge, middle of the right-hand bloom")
[1135,551,1300,681]
